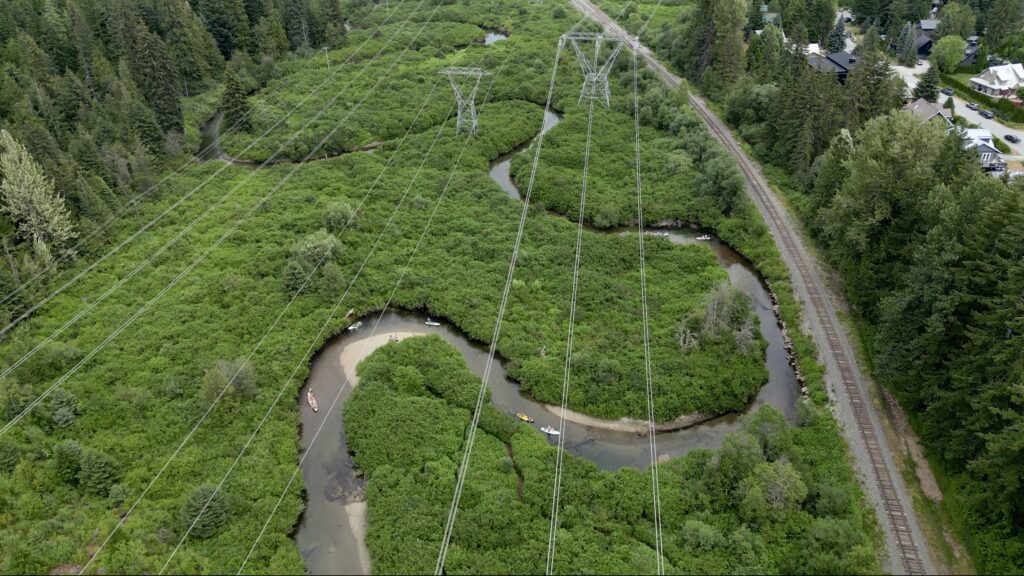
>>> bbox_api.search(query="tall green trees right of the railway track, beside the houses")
[601,0,1024,573]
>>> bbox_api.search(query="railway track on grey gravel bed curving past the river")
[569,0,934,574]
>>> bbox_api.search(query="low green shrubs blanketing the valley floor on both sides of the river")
[0,0,879,573]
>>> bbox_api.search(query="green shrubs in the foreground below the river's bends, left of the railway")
[345,336,879,574]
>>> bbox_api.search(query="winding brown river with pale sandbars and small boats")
[295,106,800,574]
